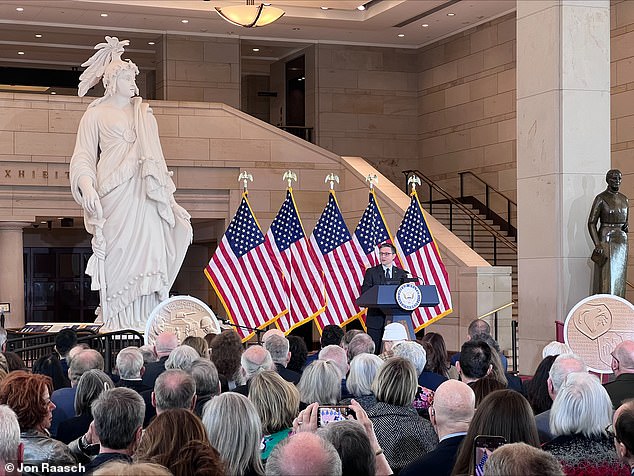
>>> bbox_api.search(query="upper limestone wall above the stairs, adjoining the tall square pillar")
[412,13,517,214]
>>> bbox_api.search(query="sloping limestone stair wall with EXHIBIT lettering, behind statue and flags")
[0,93,510,354]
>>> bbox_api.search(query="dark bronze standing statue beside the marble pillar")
[588,169,629,297]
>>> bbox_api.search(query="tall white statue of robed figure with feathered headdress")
[70,36,192,331]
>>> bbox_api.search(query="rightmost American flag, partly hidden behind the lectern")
[394,192,452,331]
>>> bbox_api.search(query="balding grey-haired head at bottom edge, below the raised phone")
[266,432,342,476]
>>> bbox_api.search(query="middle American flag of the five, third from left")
[310,190,365,330]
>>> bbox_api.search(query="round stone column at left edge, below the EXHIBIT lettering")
[0,221,30,327]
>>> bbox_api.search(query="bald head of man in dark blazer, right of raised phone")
[430,380,475,438]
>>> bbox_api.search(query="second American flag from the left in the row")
[266,188,325,333]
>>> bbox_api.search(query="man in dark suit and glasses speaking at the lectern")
[361,243,407,354]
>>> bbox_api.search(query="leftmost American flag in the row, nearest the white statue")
[205,192,286,341]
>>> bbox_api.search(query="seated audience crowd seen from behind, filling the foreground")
[0,320,634,476]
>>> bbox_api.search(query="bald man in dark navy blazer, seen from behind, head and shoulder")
[399,380,475,476]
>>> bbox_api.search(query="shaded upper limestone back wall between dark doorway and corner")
[315,44,418,188]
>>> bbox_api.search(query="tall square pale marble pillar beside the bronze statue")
[517,0,610,372]
